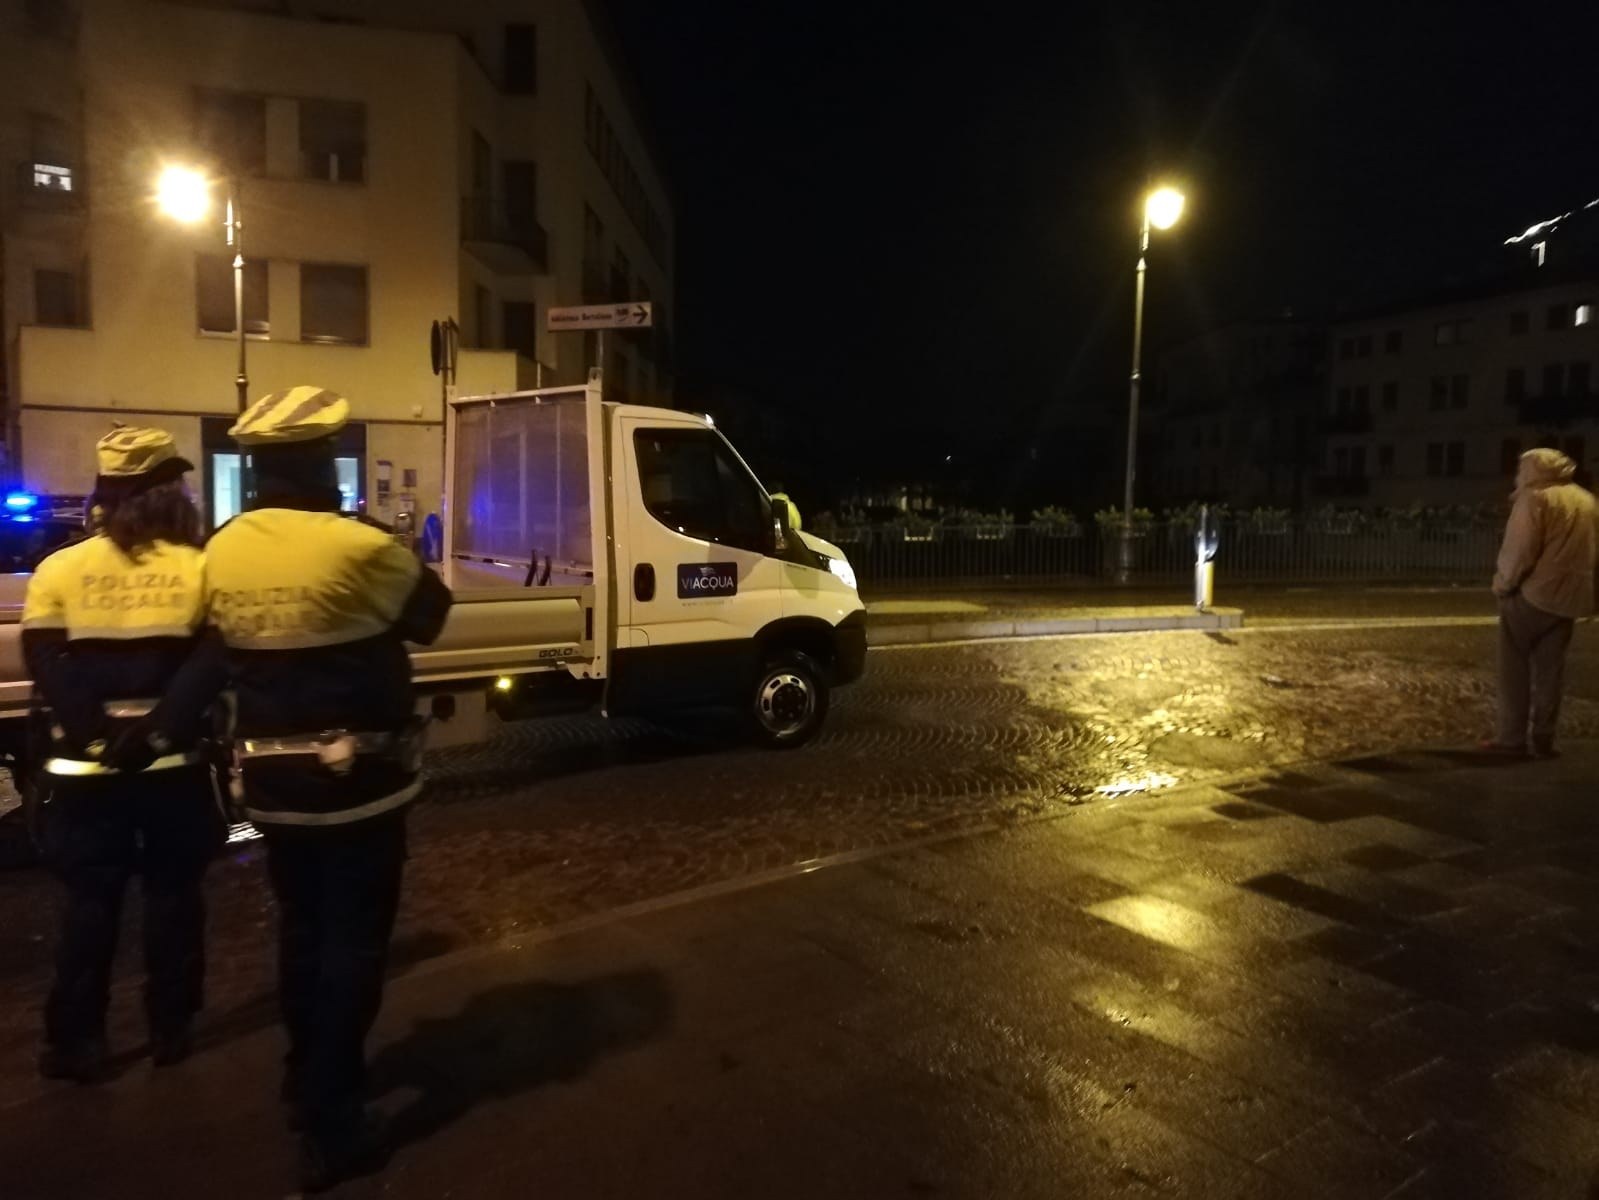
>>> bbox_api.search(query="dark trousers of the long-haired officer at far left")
[43,766,225,1050]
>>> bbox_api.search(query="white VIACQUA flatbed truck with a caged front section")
[0,379,867,790]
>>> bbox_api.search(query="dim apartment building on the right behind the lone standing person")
[1319,261,1599,509]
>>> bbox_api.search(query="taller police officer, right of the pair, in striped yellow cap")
[206,387,451,1189]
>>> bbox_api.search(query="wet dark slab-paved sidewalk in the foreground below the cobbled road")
[9,729,1599,1200]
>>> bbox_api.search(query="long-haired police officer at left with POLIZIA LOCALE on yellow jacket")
[22,427,225,1083]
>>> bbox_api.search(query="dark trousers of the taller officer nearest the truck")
[262,810,406,1131]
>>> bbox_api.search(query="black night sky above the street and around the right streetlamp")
[611,0,1599,499]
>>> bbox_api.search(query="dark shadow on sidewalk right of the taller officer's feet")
[371,970,675,1149]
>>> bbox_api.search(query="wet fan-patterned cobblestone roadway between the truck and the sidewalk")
[0,627,1599,1113]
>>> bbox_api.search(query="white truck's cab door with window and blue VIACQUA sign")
[611,416,785,710]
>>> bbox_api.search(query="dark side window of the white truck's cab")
[633,429,771,554]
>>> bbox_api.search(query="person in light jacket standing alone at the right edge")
[1482,450,1599,755]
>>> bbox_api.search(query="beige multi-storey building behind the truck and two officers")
[0,0,673,522]
